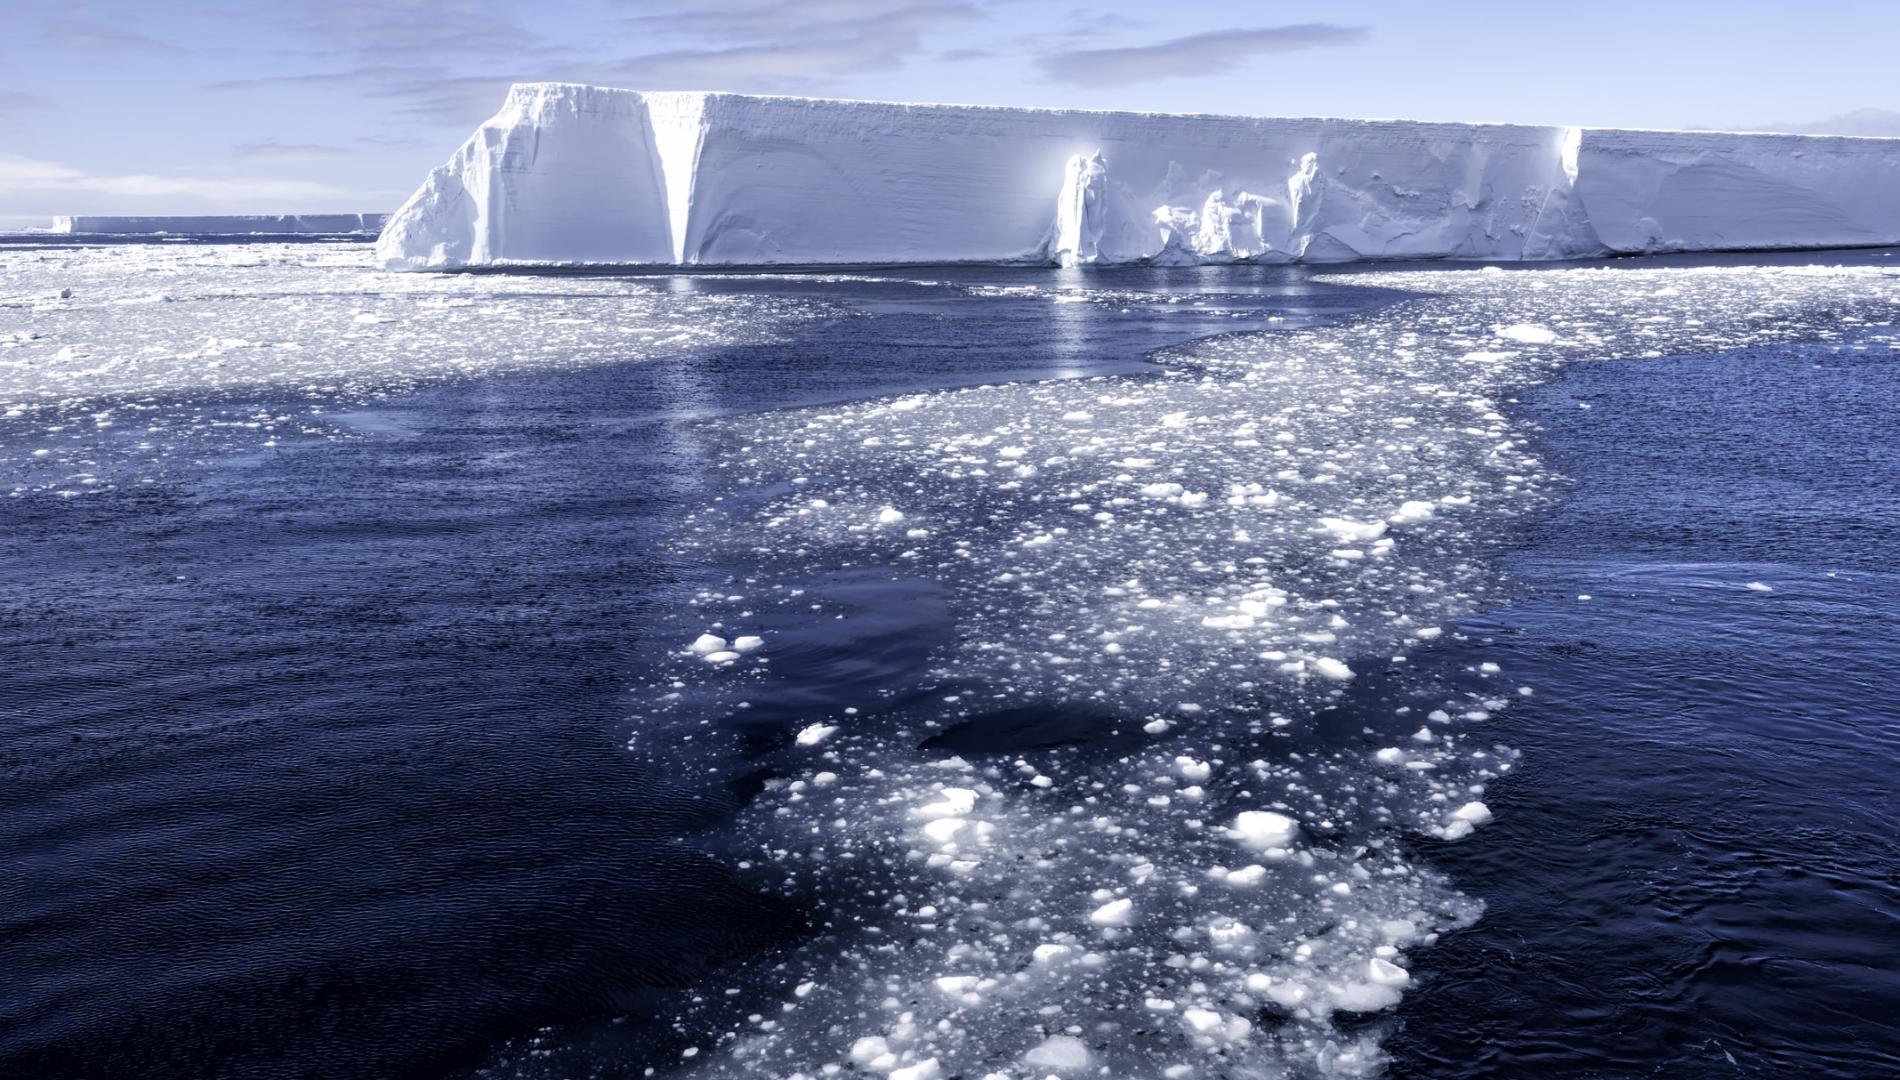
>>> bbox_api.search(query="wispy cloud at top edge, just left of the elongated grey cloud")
[610,0,984,91]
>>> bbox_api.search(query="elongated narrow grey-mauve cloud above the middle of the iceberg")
[1037,23,1368,86]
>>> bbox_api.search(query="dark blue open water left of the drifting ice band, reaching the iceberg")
[0,270,1387,1078]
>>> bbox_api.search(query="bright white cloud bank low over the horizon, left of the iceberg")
[0,154,378,213]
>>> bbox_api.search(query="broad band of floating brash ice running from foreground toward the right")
[585,258,1900,1080]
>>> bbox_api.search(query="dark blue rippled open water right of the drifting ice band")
[1391,346,1900,1078]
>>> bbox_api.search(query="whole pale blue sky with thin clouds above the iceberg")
[0,0,1900,219]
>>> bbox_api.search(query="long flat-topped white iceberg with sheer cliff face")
[376,84,1900,270]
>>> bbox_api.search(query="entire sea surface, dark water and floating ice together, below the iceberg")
[0,245,1900,1080]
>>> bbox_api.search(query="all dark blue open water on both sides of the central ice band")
[0,254,1900,1078]
